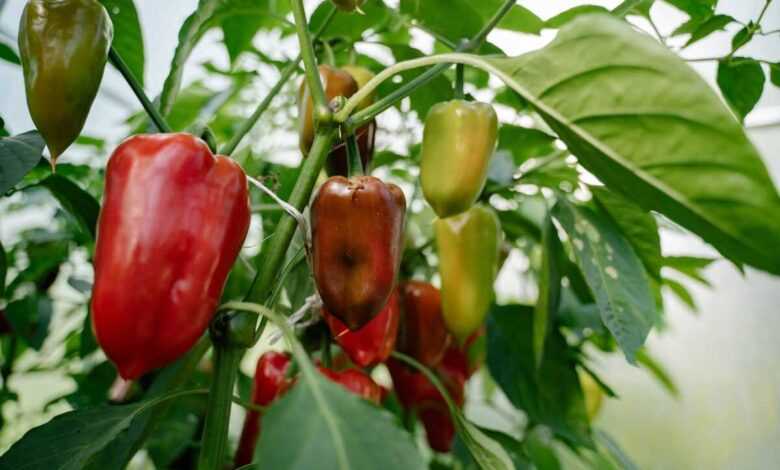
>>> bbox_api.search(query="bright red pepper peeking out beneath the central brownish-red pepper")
[322,292,400,367]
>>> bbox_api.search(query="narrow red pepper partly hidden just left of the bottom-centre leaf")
[233,351,292,468]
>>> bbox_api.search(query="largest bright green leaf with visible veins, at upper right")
[482,15,780,274]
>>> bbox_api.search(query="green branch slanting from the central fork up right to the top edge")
[336,0,516,129]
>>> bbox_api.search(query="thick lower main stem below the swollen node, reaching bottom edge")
[198,345,244,470]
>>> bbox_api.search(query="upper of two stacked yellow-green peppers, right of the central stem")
[420,100,498,218]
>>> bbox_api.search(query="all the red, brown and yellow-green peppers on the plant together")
[19,0,500,465]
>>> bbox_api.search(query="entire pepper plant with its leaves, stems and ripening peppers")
[0,0,780,470]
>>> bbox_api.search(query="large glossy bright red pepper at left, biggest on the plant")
[92,134,250,380]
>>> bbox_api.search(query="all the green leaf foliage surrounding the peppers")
[0,0,780,469]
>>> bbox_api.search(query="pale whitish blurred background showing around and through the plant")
[0,0,780,469]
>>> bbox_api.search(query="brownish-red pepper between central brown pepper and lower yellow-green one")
[397,281,451,367]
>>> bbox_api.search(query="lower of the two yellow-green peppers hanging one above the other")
[434,205,501,342]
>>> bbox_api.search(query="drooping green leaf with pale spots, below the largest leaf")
[553,199,657,364]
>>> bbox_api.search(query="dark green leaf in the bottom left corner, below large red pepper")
[0,395,192,470]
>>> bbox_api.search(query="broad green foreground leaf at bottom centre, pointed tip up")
[254,363,425,470]
